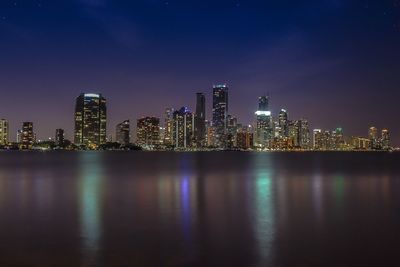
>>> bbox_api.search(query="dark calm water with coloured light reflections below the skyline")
[0,152,400,267]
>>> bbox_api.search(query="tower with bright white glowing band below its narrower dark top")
[254,96,274,149]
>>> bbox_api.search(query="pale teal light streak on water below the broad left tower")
[78,152,104,264]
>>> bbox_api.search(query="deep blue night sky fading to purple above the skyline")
[0,0,400,145]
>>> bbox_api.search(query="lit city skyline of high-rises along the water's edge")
[0,89,397,150]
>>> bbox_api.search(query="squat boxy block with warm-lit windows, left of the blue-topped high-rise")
[136,117,160,148]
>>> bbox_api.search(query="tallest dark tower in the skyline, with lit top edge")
[212,84,228,148]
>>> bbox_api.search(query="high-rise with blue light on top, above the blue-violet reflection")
[173,107,194,149]
